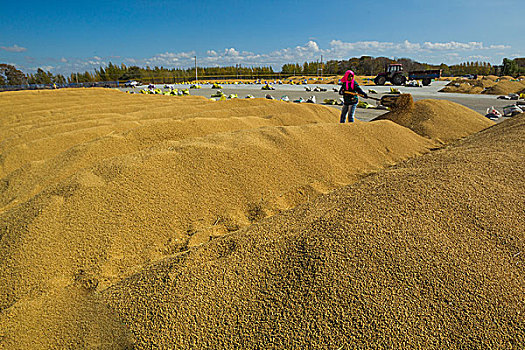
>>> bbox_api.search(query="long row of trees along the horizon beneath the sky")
[0,56,525,85]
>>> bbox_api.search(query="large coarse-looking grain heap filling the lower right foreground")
[103,114,525,349]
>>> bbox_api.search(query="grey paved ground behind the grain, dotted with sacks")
[121,81,513,121]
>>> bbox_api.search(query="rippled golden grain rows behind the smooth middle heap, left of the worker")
[0,89,338,177]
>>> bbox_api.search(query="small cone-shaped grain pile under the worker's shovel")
[375,100,494,143]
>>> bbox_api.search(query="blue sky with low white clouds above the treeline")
[0,0,525,74]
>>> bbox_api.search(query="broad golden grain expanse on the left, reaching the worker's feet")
[0,89,442,349]
